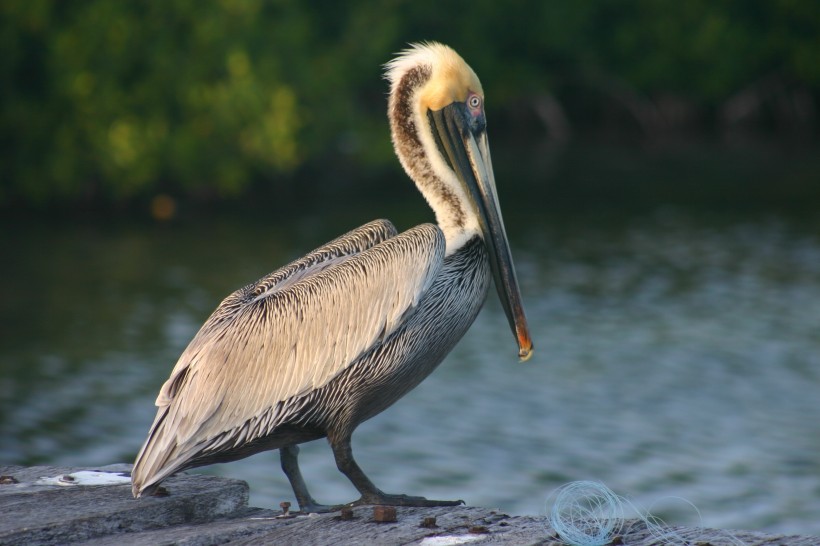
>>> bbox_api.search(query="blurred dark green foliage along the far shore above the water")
[0,0,820,205]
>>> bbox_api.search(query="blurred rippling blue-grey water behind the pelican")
[0,208,820,533]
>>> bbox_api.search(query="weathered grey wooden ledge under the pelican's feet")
[0,465,820,546]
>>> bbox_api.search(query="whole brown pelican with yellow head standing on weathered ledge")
[132,43,532,511]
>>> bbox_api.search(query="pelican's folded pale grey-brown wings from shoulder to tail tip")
[134,218,445,491]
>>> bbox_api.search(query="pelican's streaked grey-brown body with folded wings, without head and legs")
[132,220,490,494]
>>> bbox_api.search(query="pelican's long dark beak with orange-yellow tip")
[429,103,533,361]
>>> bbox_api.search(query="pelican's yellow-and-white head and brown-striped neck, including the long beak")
[386,43,532,360]
